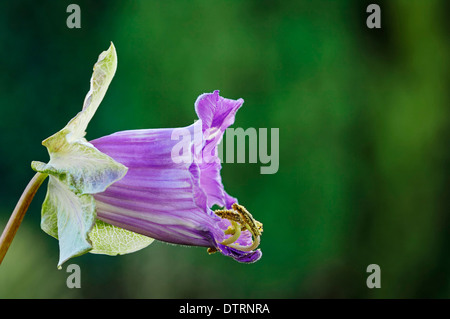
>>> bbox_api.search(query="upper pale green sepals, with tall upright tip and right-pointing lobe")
[32,43,127,194]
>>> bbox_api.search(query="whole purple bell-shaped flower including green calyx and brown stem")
[0,43,262,267]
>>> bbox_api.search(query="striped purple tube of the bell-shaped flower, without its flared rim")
[91,127,220,246]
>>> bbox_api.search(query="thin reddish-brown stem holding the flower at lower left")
[0,173,48,264]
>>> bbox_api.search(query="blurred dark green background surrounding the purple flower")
[0,0,450,298]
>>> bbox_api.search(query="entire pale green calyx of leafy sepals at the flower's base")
[31,43,153,268]
